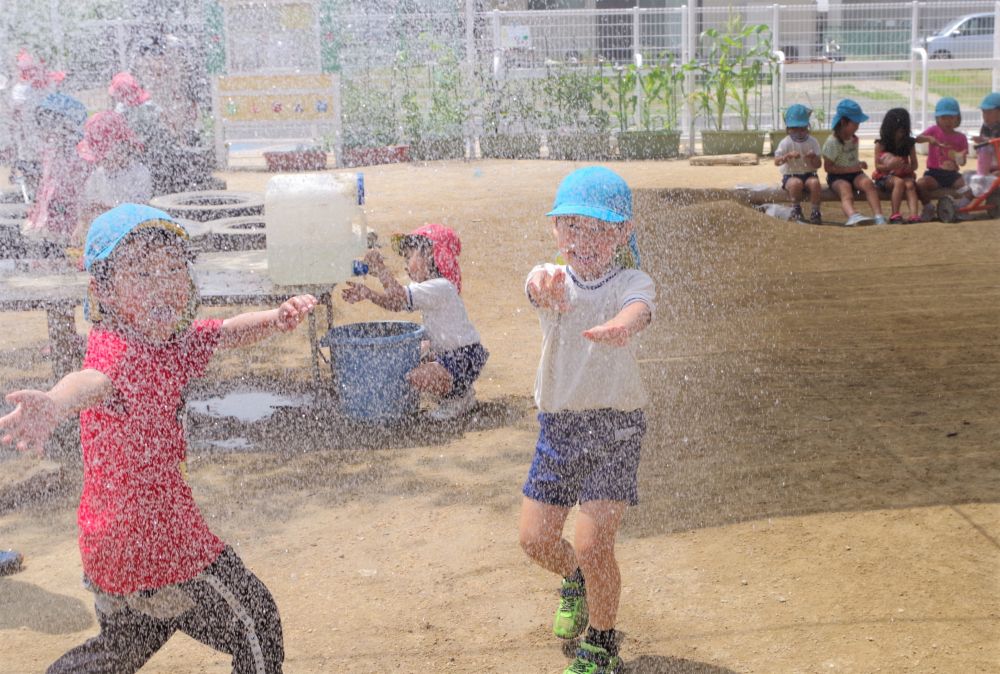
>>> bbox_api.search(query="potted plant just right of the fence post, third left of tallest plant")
[479,79,542,159]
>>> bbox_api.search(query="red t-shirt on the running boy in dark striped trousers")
[77,320,225,594]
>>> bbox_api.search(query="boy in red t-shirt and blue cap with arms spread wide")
[0,204,316,674]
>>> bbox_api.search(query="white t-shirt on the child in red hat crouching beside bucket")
[406,278,479,353]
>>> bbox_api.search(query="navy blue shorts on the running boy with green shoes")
[522,409,646,508]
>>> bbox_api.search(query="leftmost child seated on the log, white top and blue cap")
[774,103,823,224]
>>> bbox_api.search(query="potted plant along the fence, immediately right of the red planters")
[402,44,469,160]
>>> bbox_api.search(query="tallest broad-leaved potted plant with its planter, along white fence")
[685,14,775,154]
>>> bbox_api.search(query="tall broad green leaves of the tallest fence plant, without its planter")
[684,14,775,131]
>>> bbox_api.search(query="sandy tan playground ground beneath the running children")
[0,155,1000,674]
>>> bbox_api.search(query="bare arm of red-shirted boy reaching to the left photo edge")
[0,370,114,454]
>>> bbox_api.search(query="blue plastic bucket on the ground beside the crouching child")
[319,321,424,421]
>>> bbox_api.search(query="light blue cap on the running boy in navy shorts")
[546,166,632,222]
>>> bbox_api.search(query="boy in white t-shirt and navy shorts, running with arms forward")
[520,166,656,674]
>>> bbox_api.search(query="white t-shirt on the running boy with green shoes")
[528,264,656,412]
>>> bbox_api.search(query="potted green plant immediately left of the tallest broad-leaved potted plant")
[618,55,684,159]
